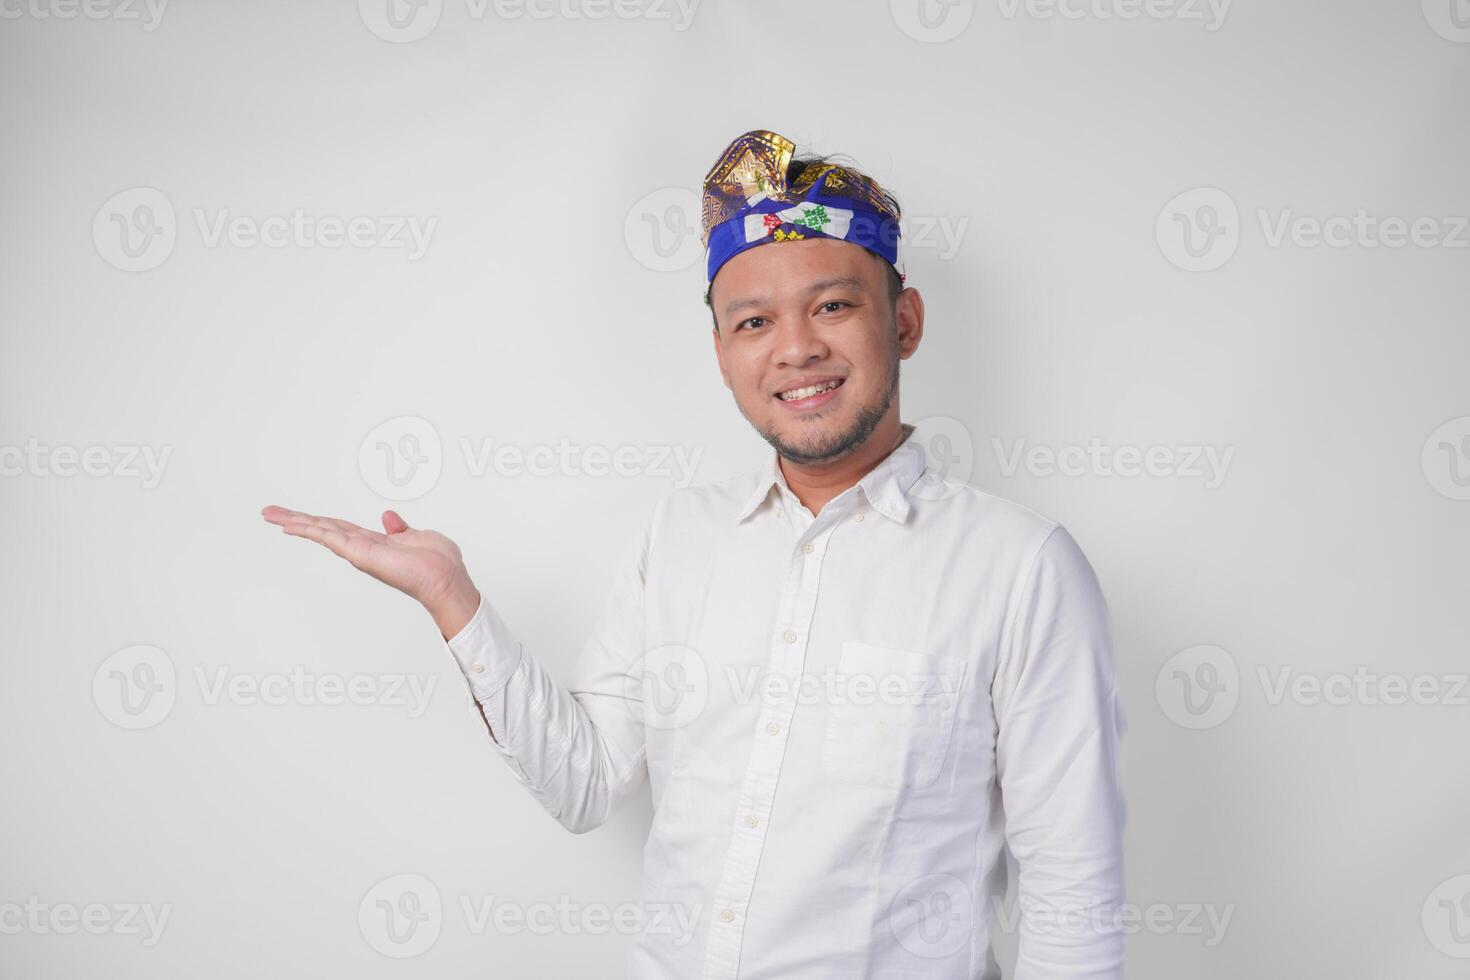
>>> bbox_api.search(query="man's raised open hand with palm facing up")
[260,504,479,639]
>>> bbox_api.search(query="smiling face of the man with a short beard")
[710,238,923,463]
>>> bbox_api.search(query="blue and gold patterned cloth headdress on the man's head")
[701,129,900,282]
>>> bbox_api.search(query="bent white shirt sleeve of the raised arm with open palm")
[444,501,663,833]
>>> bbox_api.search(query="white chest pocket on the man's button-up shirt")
[822,641,964,788]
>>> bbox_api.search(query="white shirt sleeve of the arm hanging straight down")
[992,526,1126,980]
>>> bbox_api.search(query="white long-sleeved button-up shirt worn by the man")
[445,425,1125,980]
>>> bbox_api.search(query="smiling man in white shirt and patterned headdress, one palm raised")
[265,131,1123,980]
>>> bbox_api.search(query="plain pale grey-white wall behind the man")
[0,0,1470,980]
